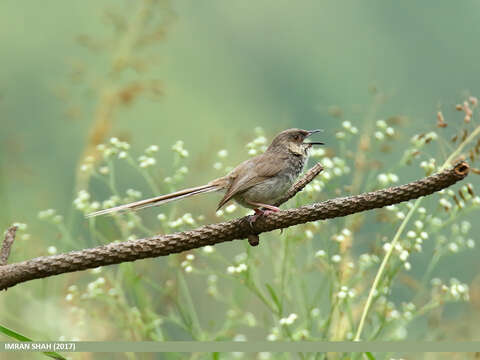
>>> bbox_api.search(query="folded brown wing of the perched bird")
[217,154,285,210]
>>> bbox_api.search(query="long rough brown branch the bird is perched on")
[0,161,469,289]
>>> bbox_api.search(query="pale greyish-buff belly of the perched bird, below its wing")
[234,175,295,209]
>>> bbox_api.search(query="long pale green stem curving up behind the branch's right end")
[353,126,480,341]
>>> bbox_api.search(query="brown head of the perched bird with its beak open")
[267,129,323,156]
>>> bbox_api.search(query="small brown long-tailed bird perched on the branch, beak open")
[87,129,323,220]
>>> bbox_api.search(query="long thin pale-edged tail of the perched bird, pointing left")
[86,184,222,217]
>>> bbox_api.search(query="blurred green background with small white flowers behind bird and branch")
[0,0,480,359]
